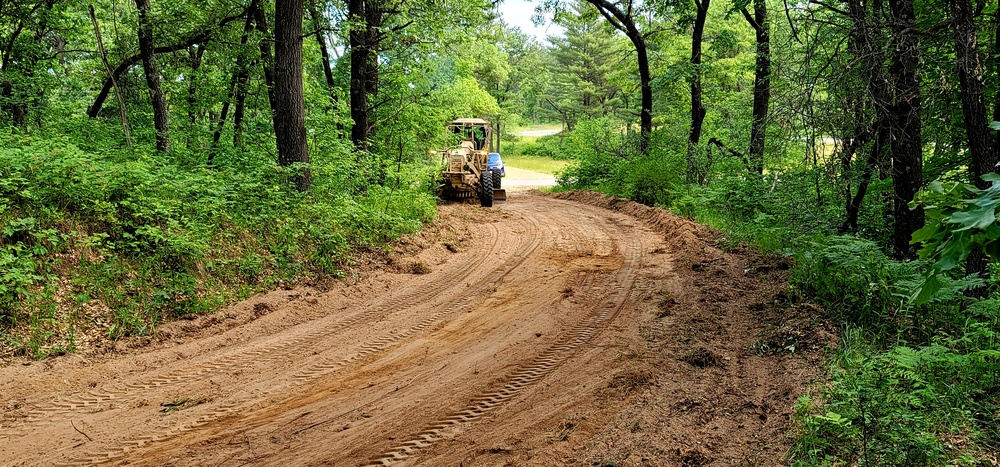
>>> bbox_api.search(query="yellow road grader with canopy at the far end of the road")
[428,118,507,208]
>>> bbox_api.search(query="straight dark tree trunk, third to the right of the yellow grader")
[742,0,771,174]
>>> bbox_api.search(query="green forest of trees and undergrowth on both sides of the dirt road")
[0,0,1000,466]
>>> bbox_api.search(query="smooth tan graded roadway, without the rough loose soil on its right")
[0,195,670,466]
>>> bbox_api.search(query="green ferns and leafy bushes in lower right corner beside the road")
[791,237,1000,466]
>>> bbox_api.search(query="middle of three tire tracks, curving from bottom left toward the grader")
[43,217,552,466]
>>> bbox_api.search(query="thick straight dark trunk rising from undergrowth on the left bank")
[273,0,312,191]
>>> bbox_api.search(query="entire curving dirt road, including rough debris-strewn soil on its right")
[0,194,822,466]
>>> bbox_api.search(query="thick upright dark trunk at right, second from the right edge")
[889,0,924,259]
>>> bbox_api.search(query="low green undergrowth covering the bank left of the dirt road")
[0,134,436,358]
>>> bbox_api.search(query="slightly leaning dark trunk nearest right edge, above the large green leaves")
[951,0,998,288]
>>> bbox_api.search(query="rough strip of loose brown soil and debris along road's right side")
[553,192,837,466]
